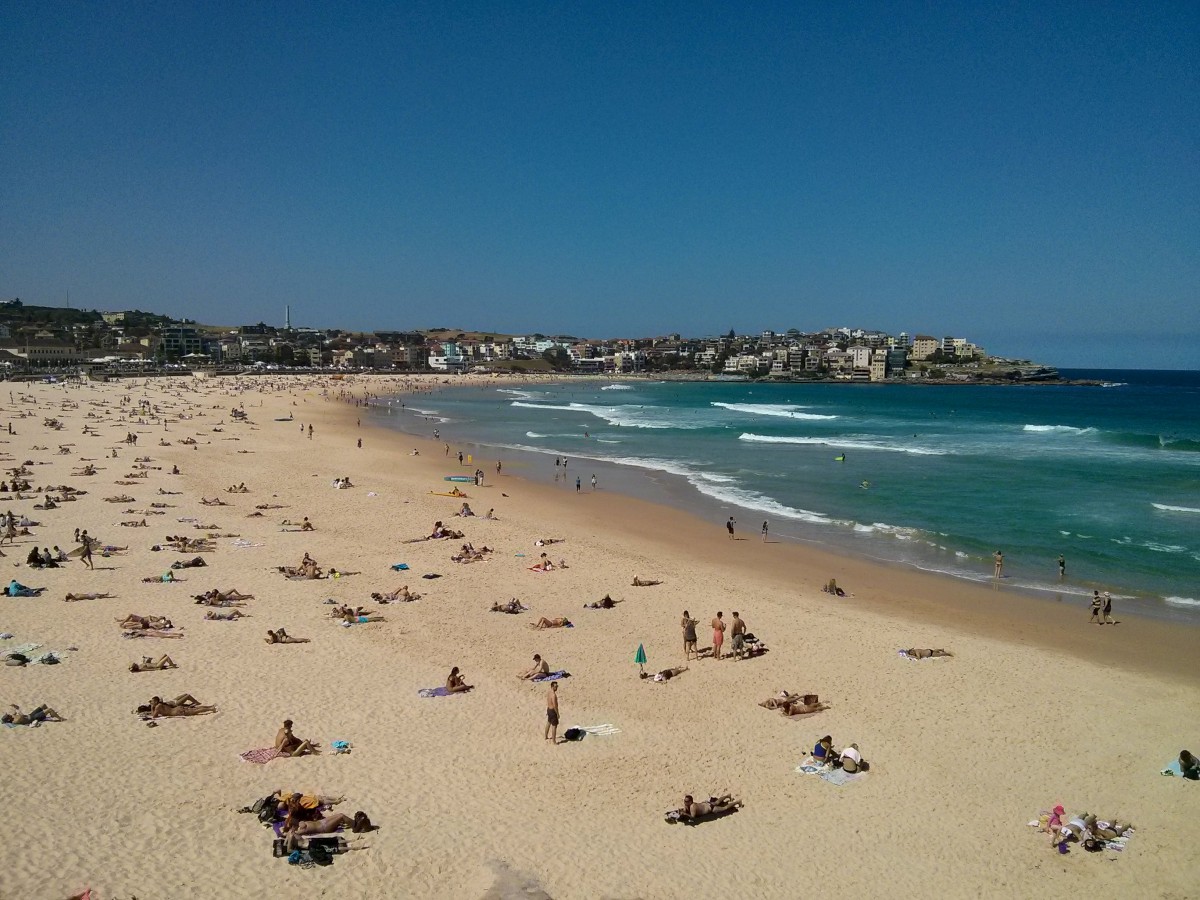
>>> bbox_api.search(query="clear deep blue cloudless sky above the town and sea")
[0,0,1200,368]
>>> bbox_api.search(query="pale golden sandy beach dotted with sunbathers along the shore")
[0,377,1200,900]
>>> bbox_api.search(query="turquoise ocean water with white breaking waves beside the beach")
[374,371,1200,622]
